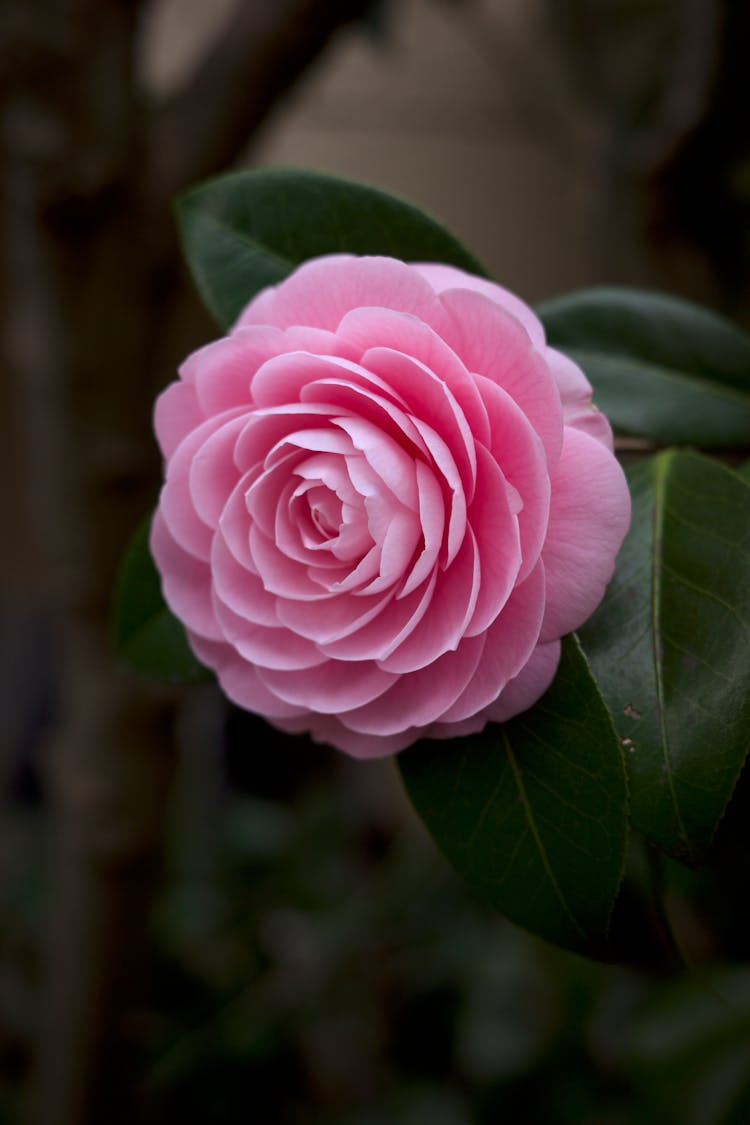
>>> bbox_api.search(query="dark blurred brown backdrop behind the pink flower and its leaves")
[0,0,750,1125]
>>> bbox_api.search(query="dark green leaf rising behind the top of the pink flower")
[177,169,486,329]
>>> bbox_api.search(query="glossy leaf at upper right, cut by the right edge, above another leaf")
[537,288,750,449]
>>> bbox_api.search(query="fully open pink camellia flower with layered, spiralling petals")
[151,254,630,758]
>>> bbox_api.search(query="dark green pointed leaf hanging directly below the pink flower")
[398,637,627,955]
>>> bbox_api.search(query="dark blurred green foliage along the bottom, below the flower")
[0,686,750,1125]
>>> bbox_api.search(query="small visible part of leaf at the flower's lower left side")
[114,518,210,683]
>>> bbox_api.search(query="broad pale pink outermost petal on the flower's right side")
[541,426,630,641]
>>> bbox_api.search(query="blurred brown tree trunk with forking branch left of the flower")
[0,0,373,1125]
